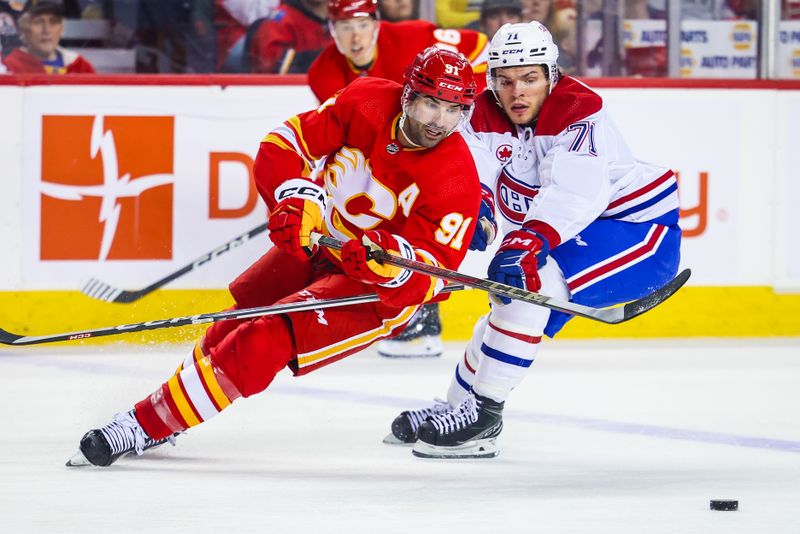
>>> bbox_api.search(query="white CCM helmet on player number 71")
[486,20,558,91]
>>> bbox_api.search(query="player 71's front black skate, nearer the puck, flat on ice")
[412,391,505,458]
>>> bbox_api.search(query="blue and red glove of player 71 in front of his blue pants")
[489,226,550,304]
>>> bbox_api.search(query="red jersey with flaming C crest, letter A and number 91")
[253,78,480,308]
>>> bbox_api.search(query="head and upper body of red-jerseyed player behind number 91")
[308,0,487,102]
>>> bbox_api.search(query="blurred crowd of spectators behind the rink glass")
[0,0,788,75]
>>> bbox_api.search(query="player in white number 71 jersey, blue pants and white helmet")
[392,22,681,458]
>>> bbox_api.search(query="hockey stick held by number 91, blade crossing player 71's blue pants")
[311,232,692,324]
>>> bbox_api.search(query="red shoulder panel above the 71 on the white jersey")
[536,76,603,135]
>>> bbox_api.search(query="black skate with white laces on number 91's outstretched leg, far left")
[67,410,175,467]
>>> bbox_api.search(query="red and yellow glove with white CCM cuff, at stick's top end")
[267,178,327,258]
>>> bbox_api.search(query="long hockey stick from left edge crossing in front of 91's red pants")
[0,284,464,346]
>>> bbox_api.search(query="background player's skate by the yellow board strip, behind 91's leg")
[376,304,444,358]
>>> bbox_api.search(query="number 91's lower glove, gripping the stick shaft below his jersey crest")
[342,230,415,287]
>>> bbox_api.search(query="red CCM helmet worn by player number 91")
[405,46,477,106]
